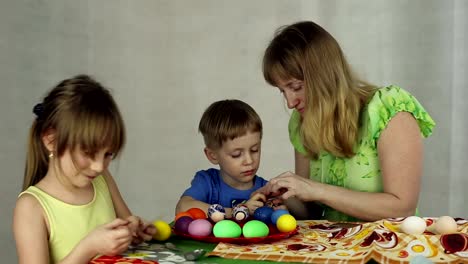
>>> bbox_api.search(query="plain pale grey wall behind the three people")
[0,0,468,263]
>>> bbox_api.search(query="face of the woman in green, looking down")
[278,78,306,116]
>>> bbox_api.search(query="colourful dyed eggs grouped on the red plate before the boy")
[174,204,297,238]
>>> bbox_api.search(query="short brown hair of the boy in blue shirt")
[198,99,263,149]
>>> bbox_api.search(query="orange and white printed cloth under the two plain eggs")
[208,218,468,264]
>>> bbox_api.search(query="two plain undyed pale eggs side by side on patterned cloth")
[400,216,457,235]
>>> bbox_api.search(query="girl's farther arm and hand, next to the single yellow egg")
[103,170,156,243]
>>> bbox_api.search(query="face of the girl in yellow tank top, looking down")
[56,148,113,188]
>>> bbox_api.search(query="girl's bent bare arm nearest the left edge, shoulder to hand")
[13,194,132,264]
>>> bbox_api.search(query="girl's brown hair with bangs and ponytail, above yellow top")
[23,75,125,190]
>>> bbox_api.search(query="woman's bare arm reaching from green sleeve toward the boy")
[272,112,423,221]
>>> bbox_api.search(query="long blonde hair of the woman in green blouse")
[263,21,376,158]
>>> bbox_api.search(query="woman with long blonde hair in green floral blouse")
[262,21,435,221]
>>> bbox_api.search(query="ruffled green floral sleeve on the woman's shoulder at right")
[368,85,435,146]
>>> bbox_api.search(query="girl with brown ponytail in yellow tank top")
[13,75,156,263]
